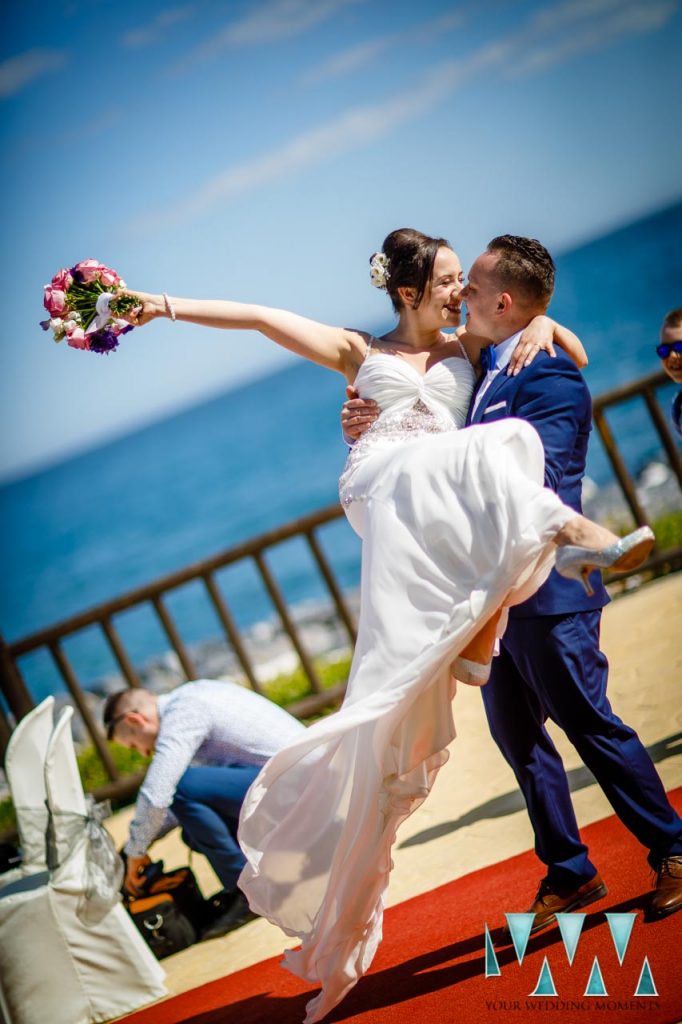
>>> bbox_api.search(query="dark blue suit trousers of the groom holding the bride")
[481,610,682,886]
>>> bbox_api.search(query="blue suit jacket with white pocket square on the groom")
[467,349,609,618]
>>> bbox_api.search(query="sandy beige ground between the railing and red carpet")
[103,573,682,993]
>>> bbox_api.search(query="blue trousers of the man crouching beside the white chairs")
[171,765,260,892]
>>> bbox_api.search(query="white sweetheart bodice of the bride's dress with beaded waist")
[339,352,475,504]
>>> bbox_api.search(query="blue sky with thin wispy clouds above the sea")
[0,0,682,478]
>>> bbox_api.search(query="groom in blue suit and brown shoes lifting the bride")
[342,234,682,931]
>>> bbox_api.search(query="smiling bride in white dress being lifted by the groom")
[123,229,651,1024]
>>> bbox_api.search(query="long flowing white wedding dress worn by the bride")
[240,351,576,1024]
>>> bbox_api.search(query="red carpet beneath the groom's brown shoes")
[125,788,682,1024]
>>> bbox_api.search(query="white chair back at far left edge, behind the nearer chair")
[0,697,54,889]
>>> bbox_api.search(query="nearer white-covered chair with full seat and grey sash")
[0,708,166,1024]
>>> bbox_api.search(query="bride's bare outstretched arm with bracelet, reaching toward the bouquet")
[126,290,367,379]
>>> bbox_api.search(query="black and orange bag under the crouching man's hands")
[126,861,208,959]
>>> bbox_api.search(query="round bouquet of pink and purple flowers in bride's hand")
[40,259,139,354]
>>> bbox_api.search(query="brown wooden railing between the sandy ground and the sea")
[0,372,682,799]
